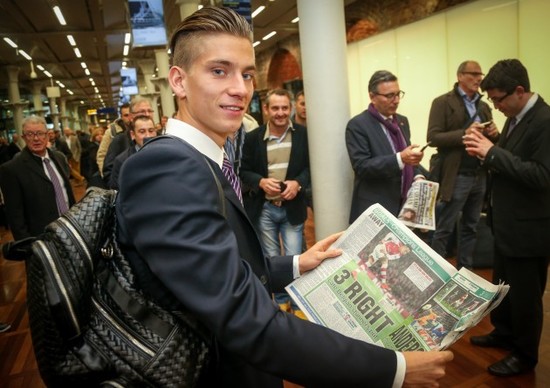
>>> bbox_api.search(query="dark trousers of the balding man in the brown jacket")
[432,173,486,269]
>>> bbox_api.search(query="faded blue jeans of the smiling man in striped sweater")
[258,201,304,309]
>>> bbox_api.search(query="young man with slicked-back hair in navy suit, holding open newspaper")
[116,7,452,388]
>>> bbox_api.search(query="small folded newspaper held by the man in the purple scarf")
[397,179,439,230]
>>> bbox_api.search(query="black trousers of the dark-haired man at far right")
[491,246,550,365]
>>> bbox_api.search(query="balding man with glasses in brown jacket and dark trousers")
[428,61,498,269]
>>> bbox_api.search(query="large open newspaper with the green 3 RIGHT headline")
[286,204,509,351]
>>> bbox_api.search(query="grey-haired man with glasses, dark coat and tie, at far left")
[0,116,75,240]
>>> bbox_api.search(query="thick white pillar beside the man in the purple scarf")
[297,0,353,240]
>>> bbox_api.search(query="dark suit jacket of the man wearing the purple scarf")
[346,110,422,224]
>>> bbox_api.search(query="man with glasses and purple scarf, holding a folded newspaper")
[346,70,424,223]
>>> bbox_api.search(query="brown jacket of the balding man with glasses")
[427,85,493,202]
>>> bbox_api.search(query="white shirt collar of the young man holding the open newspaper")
[166,118,223,168]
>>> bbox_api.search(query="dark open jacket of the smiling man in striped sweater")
[240,124,310,225]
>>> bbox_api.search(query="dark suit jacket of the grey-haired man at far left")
[0,147,75,240]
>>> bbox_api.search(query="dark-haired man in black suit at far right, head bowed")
[464,59,550,376]
